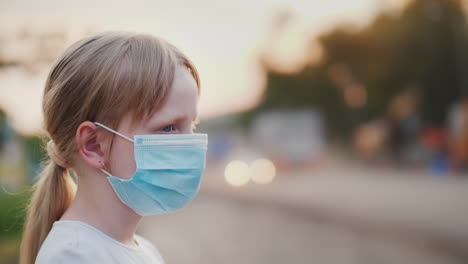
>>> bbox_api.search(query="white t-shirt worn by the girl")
[35,220,164,264]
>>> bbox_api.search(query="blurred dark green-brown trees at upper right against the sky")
[249,0,468,144]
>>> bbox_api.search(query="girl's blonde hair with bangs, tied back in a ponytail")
[20,32,200,264]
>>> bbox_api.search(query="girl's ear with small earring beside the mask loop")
[75,121,106,169]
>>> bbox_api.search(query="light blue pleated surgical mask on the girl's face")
[95,122,208,216]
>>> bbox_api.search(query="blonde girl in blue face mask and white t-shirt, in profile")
[20,32,207,264]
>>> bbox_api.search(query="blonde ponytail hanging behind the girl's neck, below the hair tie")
[20,159,76,264]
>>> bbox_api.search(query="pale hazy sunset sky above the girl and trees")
[0,0,405,134]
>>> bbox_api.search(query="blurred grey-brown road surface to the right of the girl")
[139,166,468,264]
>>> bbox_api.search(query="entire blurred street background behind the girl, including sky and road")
[0,0,468,264]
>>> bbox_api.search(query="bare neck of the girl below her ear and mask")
[60,171,142,246]
